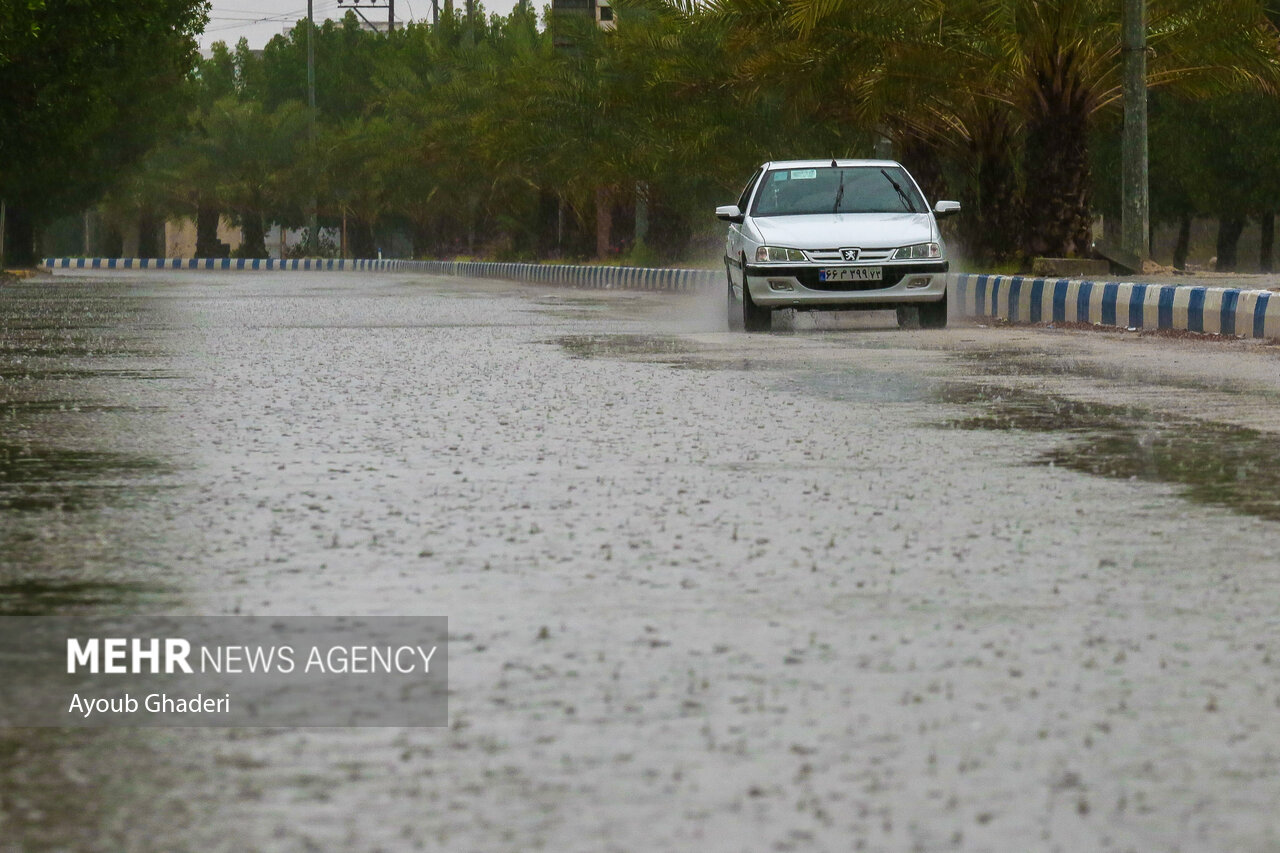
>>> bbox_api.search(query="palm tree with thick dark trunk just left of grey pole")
[978,0,1280,255]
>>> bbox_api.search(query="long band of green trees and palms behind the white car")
[0,0,1280,268]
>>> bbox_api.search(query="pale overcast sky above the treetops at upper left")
[200,0,519,50]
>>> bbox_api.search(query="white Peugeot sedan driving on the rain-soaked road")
[716,160,960,332]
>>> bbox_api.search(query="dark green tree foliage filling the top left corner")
[0,0,207,263]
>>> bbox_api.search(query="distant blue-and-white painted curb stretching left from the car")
[45,257,724,292]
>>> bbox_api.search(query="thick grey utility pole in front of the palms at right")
[1120,0,1151,262]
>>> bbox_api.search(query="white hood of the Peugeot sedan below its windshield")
[751,213,936,248]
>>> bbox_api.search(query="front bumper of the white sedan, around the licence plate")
[746,261,950,310]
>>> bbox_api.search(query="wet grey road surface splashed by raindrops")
[0,273,1280,852]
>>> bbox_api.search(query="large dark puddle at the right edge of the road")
[938,386,1280,521]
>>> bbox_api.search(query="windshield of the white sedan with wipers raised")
[751,167,927,216]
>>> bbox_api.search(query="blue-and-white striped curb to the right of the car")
[950,273,1280,338]
